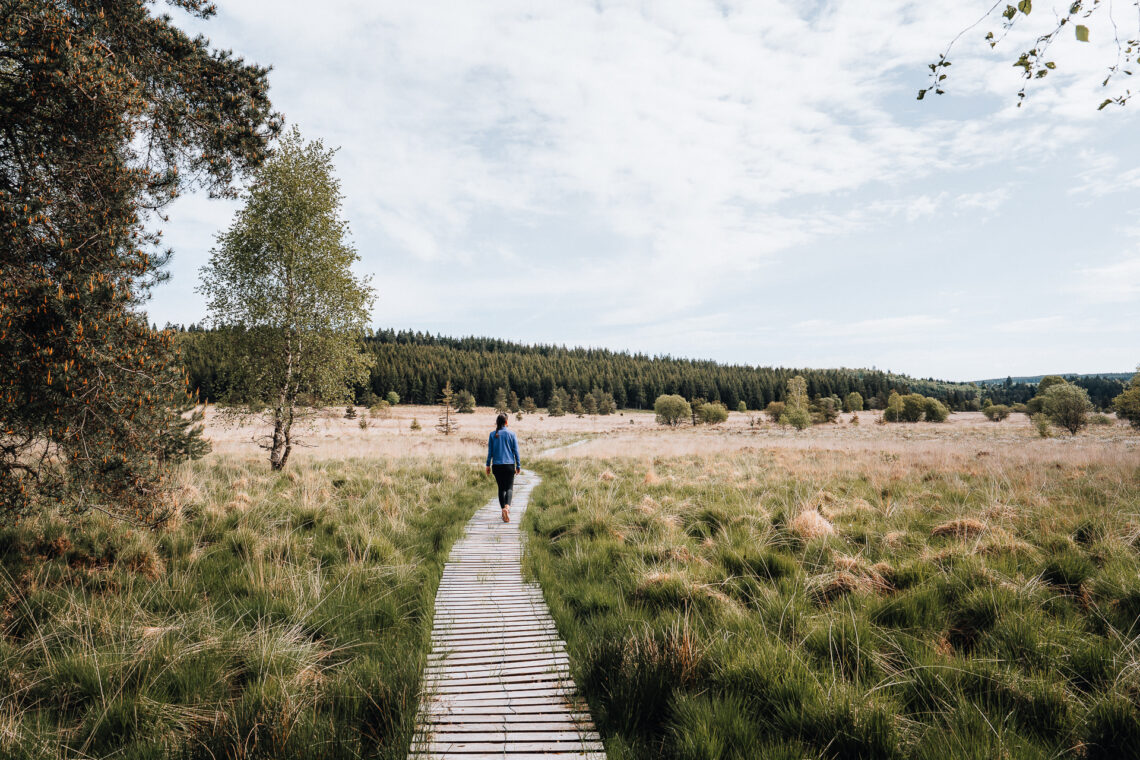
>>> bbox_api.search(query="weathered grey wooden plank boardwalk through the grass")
[409,472,605,760]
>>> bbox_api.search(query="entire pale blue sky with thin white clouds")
[147,0,1140,379]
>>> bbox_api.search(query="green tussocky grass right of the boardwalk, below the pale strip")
[526,446,1140,760]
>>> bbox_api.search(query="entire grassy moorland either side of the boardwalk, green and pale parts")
[0,406,1140,759]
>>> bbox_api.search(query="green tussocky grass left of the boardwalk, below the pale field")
[0,458,487,760]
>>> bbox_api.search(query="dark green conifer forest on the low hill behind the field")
[176,326,979,410]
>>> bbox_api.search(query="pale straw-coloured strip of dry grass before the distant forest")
[198,404,1140,459]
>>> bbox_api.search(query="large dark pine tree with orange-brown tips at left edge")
[0,0,279,522]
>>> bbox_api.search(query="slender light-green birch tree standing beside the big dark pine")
[198,128,373,469]
